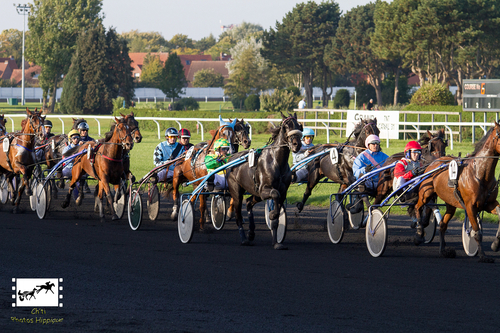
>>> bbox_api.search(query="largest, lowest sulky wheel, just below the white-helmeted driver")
[365,209,387,257]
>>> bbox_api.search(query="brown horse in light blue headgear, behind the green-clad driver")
[167,119,252,230]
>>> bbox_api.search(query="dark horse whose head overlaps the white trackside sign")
[297,118,380,213]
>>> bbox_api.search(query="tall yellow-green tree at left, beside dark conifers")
[26,0,102,111]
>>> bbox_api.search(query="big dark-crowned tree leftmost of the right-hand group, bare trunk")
[261,1,340,108]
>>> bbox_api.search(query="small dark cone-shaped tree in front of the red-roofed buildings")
[160,53,187,98]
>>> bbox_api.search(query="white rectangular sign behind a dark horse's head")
[346,110,399,139]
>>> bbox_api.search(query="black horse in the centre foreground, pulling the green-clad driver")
[228,113,302,250]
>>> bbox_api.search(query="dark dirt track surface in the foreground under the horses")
[0,188,500,332]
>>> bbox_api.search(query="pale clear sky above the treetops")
[0,0,388,40]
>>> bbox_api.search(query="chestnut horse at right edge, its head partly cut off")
[415,122,500,262]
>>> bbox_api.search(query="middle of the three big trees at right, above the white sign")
[325,1,388,105]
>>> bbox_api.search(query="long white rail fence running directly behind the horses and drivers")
[5,114,493,150]
